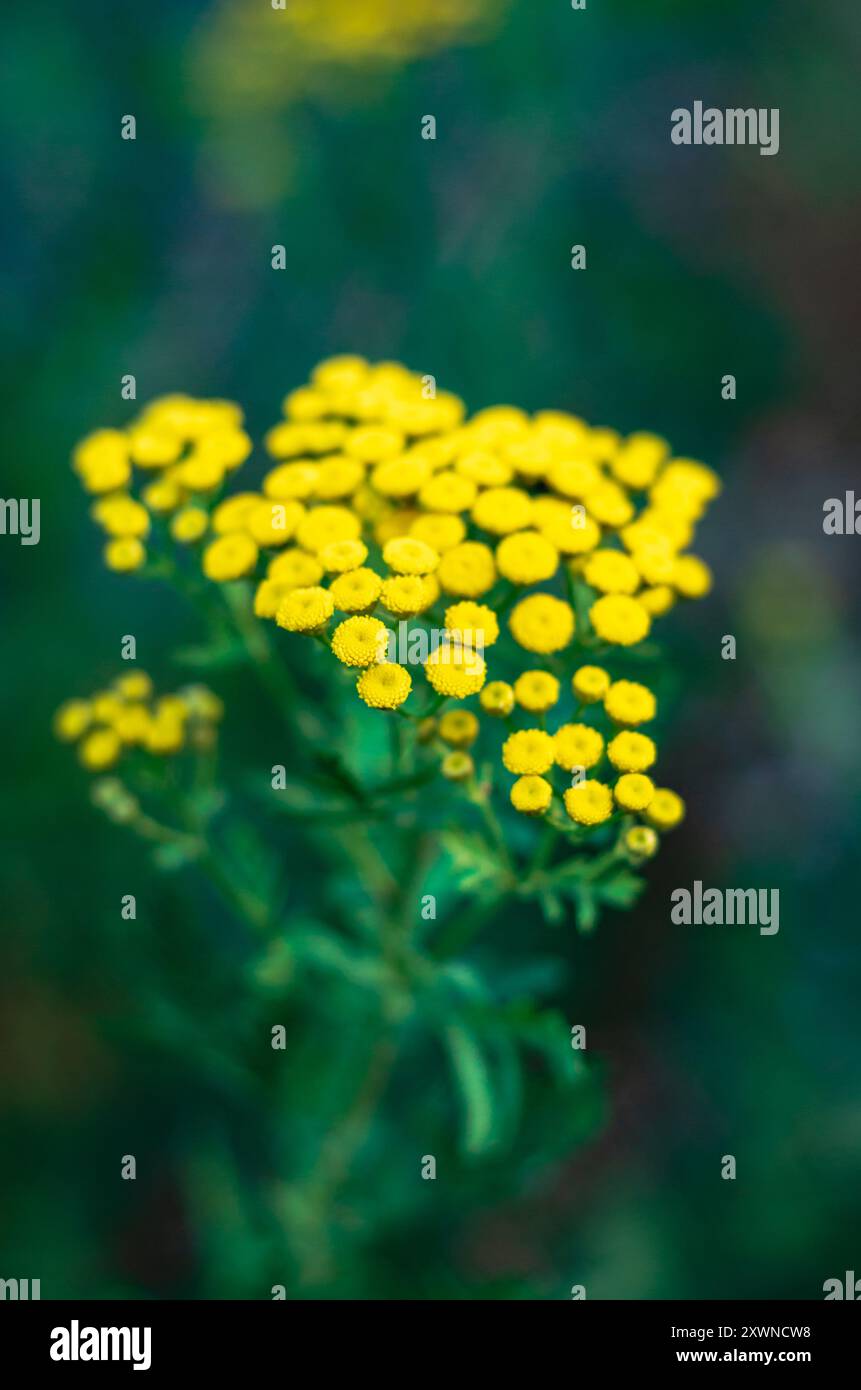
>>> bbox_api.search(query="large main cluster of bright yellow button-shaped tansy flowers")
[74,356,721,855]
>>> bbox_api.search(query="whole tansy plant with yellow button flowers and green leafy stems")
[56,356,719,1277]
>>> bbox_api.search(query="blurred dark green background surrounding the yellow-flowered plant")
[0,0,861,1298]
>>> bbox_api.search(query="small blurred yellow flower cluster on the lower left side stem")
[54,671,224,773]
